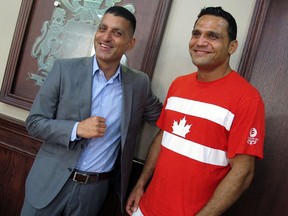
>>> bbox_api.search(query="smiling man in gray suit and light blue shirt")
[21,6,162,216]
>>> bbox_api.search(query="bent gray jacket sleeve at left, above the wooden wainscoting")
[26,61,88,149]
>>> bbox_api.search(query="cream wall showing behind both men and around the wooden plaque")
[0,0,256,159]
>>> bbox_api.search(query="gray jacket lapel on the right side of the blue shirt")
[121,66,133,150]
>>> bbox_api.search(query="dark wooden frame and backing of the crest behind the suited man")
[0,0,172,110]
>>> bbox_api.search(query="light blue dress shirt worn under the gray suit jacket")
[71,58,122,173]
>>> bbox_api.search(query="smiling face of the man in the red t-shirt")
[189,15,237,71]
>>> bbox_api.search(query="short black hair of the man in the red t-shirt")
[195,7,237,41]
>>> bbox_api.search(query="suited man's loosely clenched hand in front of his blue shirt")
[77,116,106,139]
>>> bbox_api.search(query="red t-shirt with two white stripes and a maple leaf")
[140,71,265,216]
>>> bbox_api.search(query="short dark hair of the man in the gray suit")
[105,6,136,34]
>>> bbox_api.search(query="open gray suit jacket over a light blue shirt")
[26,57,162,208]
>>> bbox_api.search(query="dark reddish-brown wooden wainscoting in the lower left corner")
[0,115,41,216]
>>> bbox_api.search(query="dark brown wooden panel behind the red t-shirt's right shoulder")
[226,0,288,216]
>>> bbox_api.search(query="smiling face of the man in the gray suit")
[94,13,135,68]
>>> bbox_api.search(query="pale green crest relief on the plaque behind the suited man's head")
[28,0,135,86]
